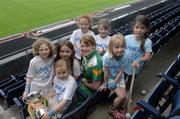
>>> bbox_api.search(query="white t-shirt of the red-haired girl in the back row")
[70,29,95,59]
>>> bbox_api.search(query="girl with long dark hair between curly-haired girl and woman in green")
[55,40,81,80]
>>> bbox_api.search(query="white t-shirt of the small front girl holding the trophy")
[53,75,77,102]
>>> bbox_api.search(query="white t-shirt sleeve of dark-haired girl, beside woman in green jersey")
[73,59,82,76]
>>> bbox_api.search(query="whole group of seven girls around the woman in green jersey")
[23,15,152,119]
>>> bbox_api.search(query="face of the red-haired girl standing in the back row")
[79,18,90,33]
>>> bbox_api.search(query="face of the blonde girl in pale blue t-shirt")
[113,40,125,57]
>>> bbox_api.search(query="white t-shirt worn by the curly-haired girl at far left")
[26,56,54,87]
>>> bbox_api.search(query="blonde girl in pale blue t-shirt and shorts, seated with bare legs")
[100,34,126,113]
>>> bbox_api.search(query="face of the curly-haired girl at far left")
[38,44,50,59]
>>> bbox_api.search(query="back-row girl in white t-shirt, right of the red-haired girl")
[94,19,111,55]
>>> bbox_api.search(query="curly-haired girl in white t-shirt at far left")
[23,38,54,99]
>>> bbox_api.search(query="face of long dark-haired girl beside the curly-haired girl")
[59,45,72,60]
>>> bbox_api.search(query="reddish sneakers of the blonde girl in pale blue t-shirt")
[109,106,125,119]
